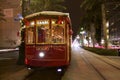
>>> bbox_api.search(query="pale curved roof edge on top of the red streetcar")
[25,11,69,18]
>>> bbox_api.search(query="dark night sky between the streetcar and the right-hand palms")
[65,0,83,37]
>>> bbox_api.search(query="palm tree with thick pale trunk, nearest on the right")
[81,0,120,49]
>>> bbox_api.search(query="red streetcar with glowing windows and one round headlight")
[23,11,72,67]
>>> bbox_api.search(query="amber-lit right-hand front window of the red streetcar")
[52,19,65,43]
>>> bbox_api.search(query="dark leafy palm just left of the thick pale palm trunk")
[81,0,101,47]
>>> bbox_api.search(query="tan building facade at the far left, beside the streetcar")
[0,0,21,48]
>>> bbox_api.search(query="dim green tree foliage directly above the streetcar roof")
[24,0,66,15]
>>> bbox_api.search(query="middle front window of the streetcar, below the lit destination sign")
[36,19,50,43]
